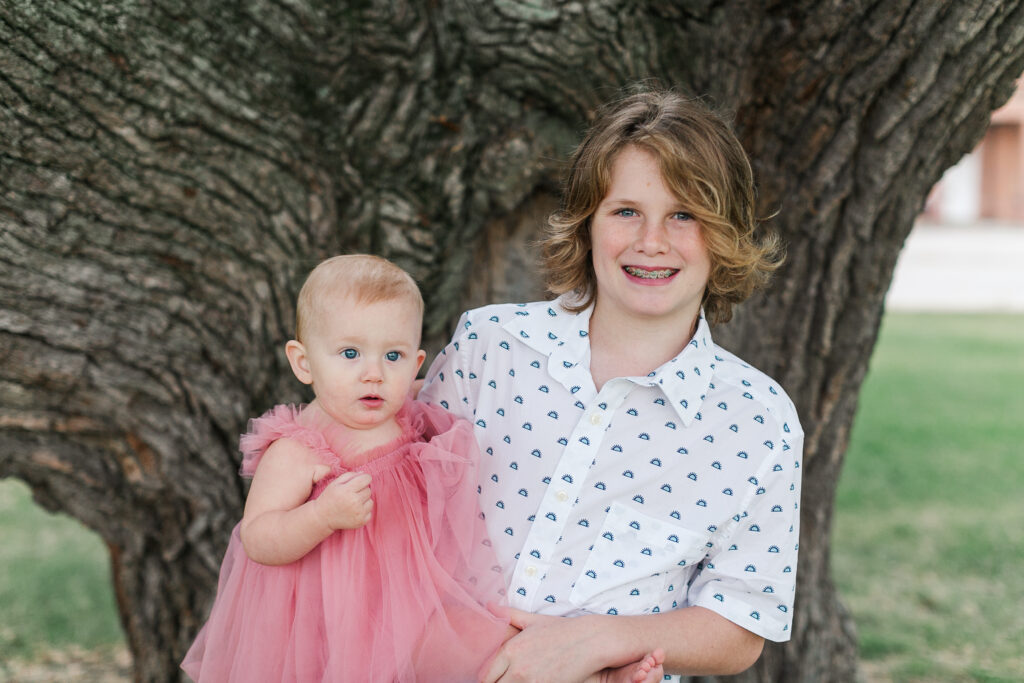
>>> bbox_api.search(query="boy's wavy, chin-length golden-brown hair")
[541,90,783,323]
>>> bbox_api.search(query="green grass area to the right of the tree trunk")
[833,314,1024,682]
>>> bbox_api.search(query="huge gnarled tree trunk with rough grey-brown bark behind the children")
[0,0,1024,682]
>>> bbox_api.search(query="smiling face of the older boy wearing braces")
[591,145,711,329]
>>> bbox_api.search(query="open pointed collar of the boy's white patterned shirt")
[502,295,715,427]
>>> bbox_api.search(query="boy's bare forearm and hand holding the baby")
[482,607,764,683]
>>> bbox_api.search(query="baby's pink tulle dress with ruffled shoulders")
[181,400,508,683]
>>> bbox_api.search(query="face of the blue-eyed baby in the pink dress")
[305,295,425,430]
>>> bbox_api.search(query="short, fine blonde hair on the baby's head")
[295,254,423,345]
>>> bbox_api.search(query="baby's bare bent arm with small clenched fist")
[240,438,373,564]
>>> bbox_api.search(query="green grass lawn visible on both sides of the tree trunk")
[0,314,1024,683]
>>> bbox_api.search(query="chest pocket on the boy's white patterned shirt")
[569,503,708,613]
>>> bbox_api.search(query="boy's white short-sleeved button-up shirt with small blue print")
[419,301,804,655]
